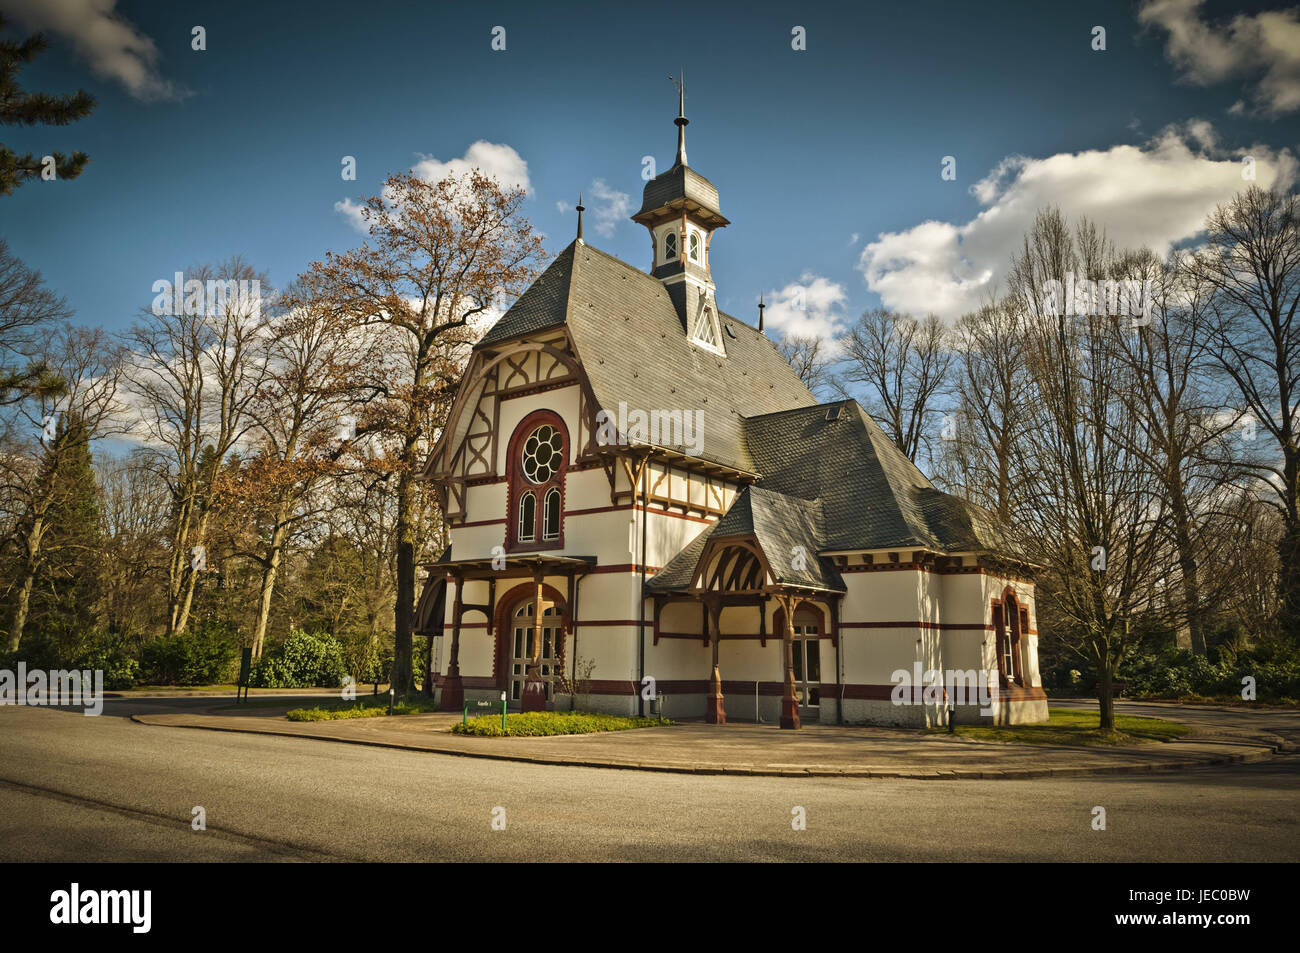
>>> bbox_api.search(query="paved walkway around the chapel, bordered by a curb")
[133,703,1291,780]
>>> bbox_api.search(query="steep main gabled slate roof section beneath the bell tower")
[477,242,816,471]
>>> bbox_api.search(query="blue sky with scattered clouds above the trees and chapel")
[0,0,1300,333]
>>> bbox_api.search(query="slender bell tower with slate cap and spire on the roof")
[632,74,731,354]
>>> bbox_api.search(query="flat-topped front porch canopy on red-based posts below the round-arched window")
[416,547,595,711]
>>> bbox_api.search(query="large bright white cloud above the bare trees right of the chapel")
[858,121,1297,319]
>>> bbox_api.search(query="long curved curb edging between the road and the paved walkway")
[130,715,1290,781]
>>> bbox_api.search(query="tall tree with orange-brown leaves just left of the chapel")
[312,170,542,694]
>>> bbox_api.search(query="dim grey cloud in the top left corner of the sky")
[0,0,190,100]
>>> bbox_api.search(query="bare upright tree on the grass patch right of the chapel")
[1011,209,1166,732]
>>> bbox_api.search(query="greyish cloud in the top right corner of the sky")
[1138,0,1300,116]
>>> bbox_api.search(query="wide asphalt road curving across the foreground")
[0,698,1300,862]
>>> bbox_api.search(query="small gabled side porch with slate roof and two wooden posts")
[646,486,845,728]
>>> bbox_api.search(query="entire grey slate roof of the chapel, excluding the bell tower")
[476,242,1014,592]
